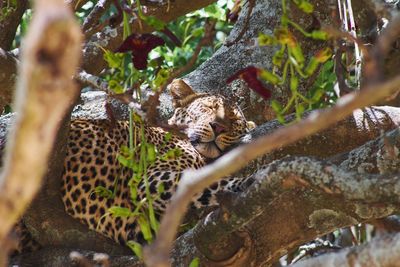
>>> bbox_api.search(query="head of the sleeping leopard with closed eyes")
[168,79,255,159]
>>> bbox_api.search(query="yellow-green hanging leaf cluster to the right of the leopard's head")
[258,0,336,123]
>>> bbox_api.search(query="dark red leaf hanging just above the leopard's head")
[226,66,272,100]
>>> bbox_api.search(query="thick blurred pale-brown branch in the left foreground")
[0,0,81,262]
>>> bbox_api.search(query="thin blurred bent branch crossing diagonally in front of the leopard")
[145,76,400,267]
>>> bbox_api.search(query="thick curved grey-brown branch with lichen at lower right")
[172,127,400,266]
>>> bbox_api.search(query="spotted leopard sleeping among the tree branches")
[19,79,255,249]
